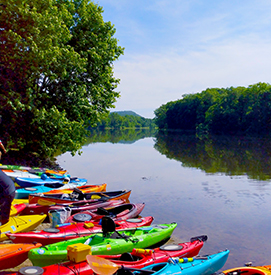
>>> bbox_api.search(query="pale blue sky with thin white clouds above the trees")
[94,0,271,118]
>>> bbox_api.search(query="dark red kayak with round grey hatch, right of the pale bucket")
[65,203,145,222]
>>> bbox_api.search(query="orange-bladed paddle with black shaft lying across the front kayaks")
[86,255,157,275]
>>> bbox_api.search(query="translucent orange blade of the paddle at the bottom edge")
[87,255,120,275]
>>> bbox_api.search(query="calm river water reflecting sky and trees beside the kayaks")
[57,135,271,269]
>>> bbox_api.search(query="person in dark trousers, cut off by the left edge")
[0,140,16,225]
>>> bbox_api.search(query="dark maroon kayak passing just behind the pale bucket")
[23,200,125,215]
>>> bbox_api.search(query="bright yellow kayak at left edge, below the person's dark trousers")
[0,215,47,241]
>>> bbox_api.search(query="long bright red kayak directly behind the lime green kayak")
[6,216,153,245]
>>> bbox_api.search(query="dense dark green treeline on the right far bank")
[154,83,271,134]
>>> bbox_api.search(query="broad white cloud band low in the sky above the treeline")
[115,35,271,116]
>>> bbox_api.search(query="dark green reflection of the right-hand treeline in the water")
[154,132,271,182]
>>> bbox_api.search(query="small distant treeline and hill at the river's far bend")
[92,112,156,129]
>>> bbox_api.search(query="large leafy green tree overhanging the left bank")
[0,0,124,156]
